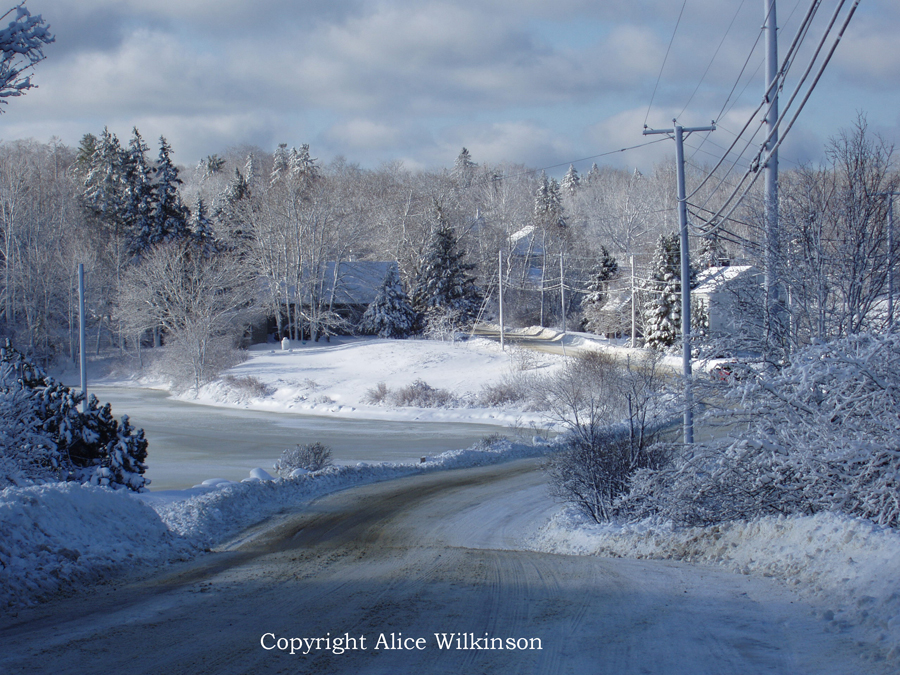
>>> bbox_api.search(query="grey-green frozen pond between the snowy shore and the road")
[90,387,512,490]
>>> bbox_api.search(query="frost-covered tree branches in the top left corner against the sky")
[0,2,56,112]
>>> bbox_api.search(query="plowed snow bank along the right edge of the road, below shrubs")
[531,509,900,661]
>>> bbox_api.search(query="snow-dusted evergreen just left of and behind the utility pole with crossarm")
[644,233,695,349]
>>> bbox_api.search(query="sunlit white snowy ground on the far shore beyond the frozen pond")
[98,338,572,426]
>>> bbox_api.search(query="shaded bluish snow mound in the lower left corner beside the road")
[0,483,191,607]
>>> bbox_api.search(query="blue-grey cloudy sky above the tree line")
[0,0,900,170]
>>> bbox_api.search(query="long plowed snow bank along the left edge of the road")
[0,440,546,607]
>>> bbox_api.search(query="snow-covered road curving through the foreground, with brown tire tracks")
[0,460,878,675]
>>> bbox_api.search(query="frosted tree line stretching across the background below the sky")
[0,116,897,383]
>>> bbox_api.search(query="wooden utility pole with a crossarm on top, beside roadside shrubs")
[644,120,716,445]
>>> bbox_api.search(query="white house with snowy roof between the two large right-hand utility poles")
[691,265,763,335]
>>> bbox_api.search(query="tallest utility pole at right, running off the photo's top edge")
[763,0,781,334]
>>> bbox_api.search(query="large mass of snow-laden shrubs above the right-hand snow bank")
[623,334,900,528]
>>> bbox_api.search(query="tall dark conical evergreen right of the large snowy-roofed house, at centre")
[413,209,481,325]
